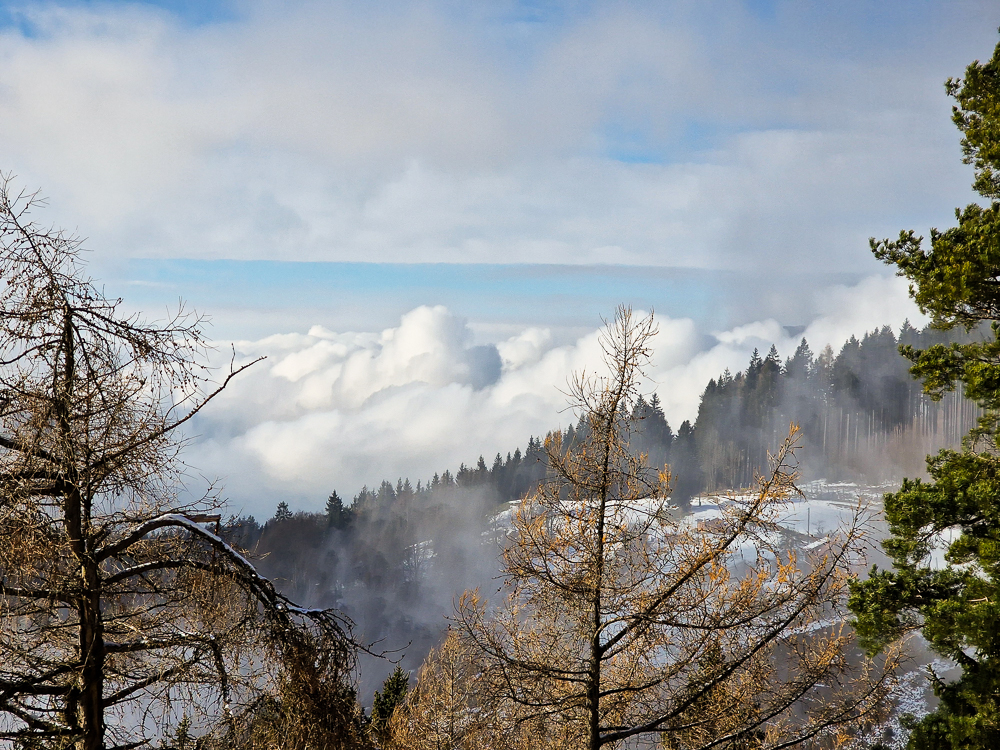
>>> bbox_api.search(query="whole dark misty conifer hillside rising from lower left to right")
[217,318,979,712]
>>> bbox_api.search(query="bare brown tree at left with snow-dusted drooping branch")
[0,178,364,750]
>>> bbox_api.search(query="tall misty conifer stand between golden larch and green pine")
[673,324,980,502]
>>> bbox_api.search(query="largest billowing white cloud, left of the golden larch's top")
[192,307,599,507]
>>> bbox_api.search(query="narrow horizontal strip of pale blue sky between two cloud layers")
[109,259,863,341]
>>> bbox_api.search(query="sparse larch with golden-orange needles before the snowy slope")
[454,308,895,750]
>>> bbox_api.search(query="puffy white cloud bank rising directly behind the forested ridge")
[195,277,924,518]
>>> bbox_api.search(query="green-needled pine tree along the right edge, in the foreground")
[851,36,1000,750]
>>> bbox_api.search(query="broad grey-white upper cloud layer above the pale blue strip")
[0,0,1000,272]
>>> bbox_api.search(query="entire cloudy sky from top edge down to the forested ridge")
[0,0,1000,502]
